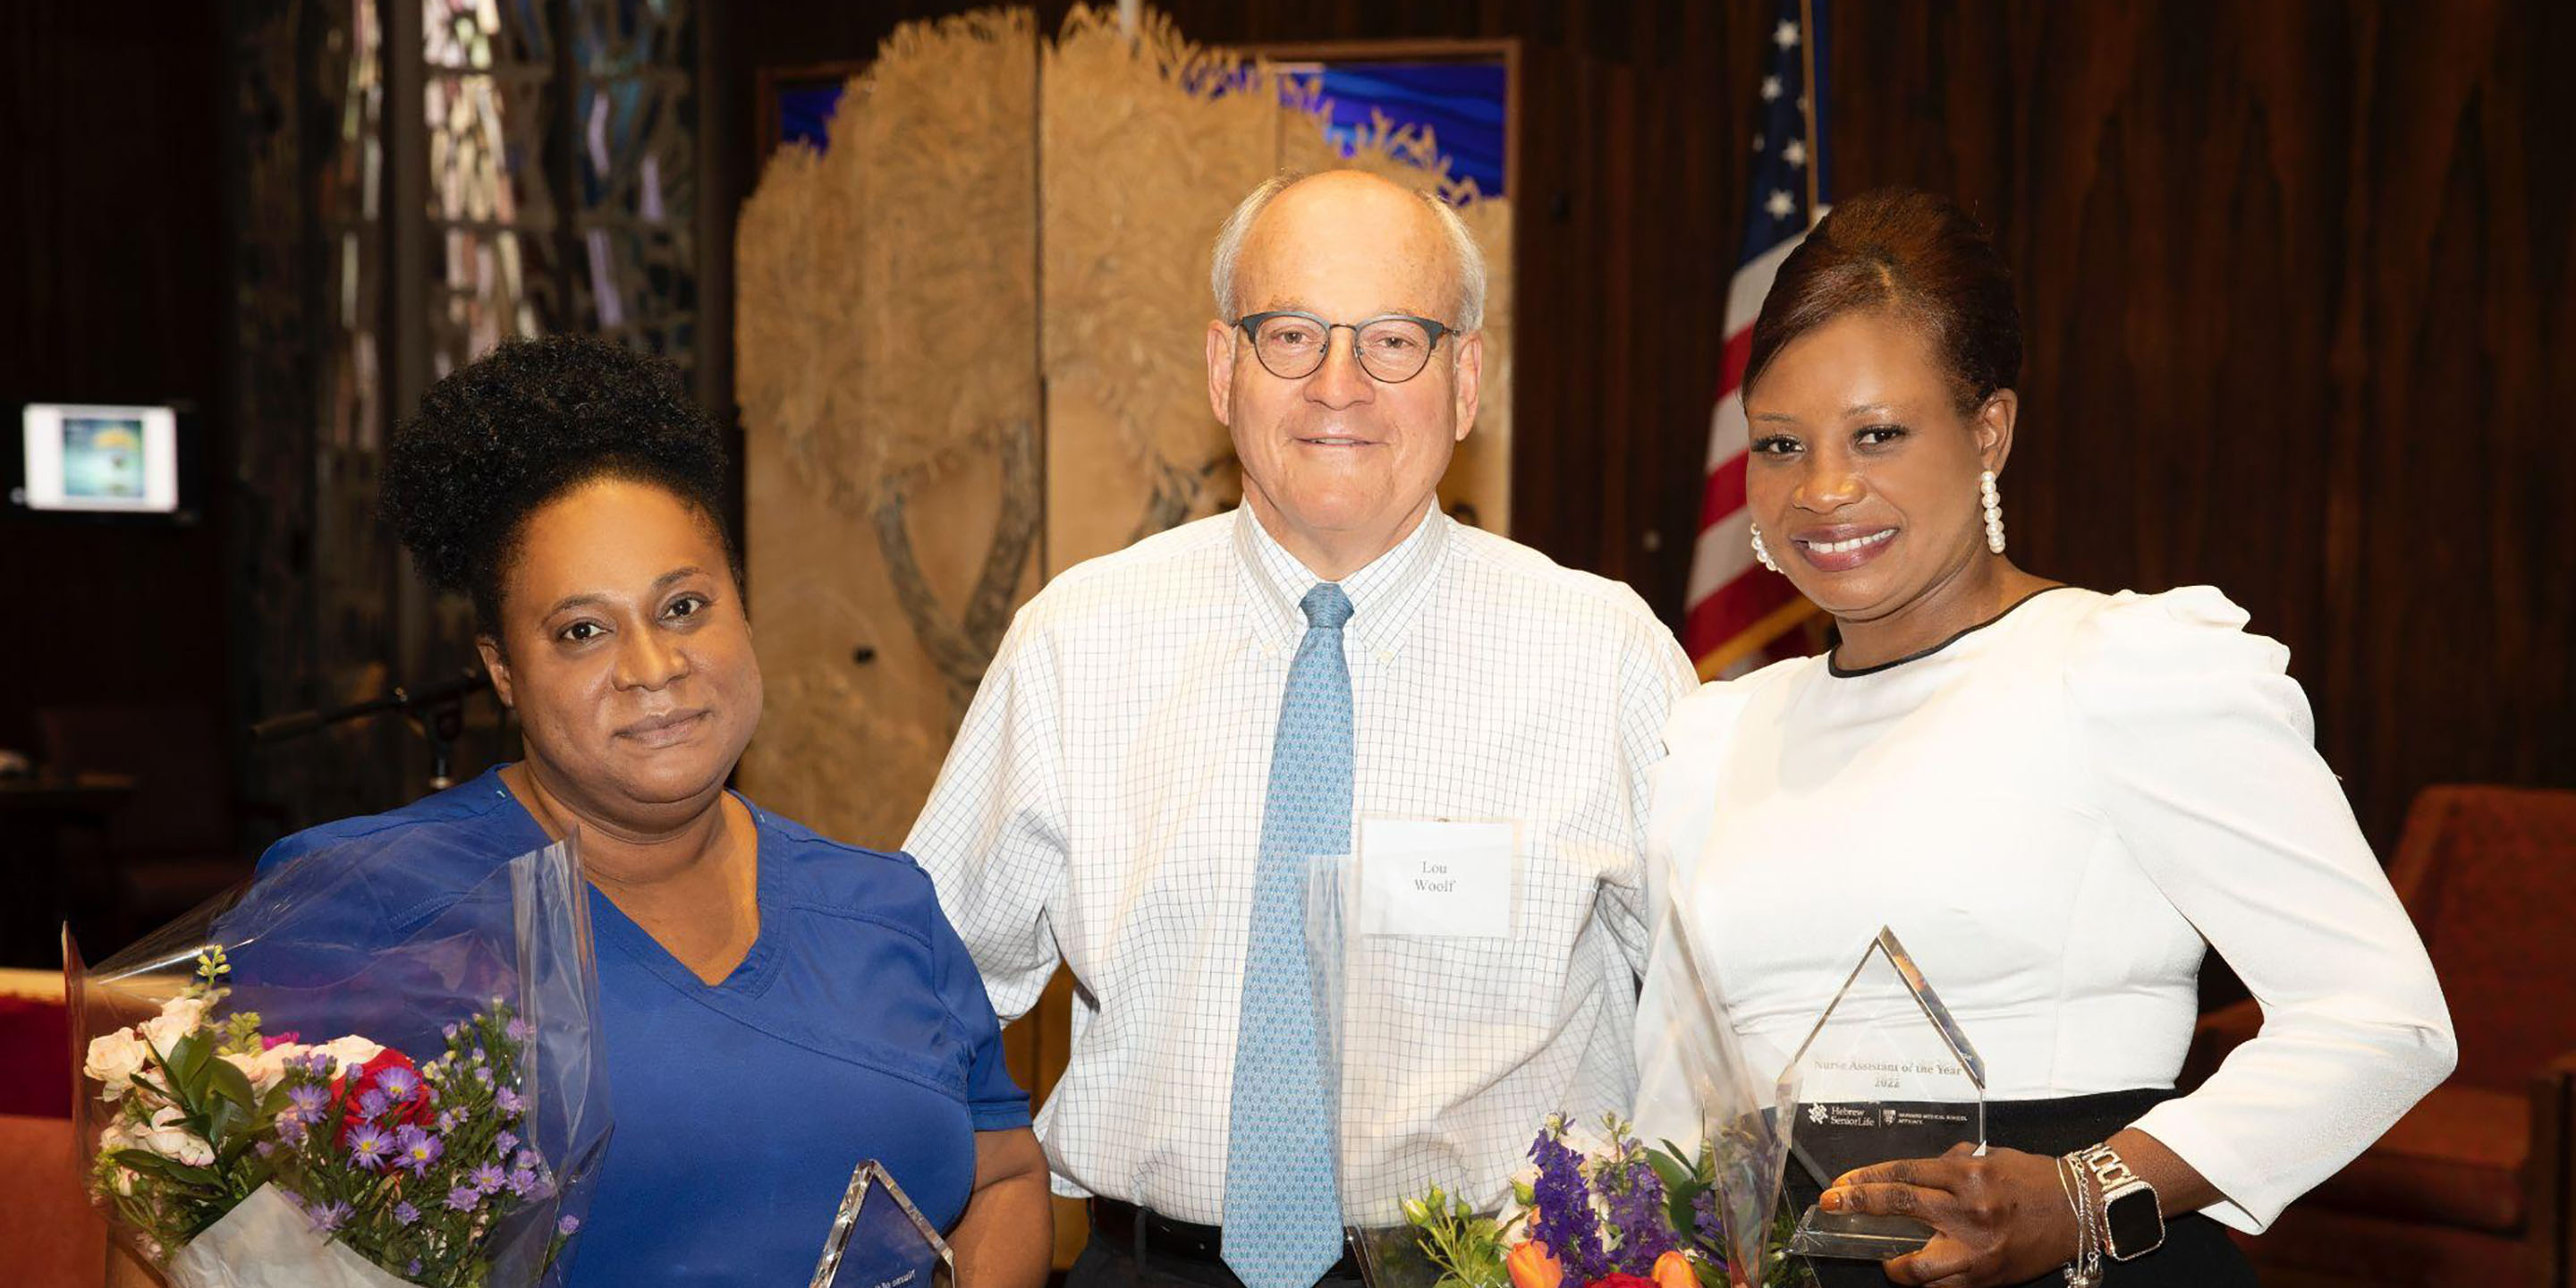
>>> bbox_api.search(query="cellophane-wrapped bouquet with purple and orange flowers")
[1306,858,1811,1288]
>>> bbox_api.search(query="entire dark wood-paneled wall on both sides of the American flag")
[711,0,2576,850]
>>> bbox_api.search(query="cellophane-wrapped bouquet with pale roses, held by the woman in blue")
[64,826,608,1288]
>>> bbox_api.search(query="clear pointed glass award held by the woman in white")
[1780,928,1986,1262]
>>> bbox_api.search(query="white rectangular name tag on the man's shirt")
[1358,817,1520,940]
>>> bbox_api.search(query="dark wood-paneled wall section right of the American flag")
[1832,0,2576,852]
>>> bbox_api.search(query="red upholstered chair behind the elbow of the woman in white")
[2187,785,2576,1288]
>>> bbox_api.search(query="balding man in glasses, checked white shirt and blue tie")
[907,170,1692,1288]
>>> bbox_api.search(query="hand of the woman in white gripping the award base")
[1821,1144,2081,1288]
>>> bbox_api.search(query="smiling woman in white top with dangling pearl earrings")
[1639,191,2455,1288]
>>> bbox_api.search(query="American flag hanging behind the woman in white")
[1682,0,1826,680]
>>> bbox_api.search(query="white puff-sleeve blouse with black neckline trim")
[1639,588,2458,1232]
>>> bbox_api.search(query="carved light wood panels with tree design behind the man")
[734,8,1513,845]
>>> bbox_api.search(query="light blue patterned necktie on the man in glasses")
[1224,582,1350,1288]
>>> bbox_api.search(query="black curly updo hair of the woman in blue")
[376,335,741,636]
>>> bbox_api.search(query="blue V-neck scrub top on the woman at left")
[260,770,1028,1288]
